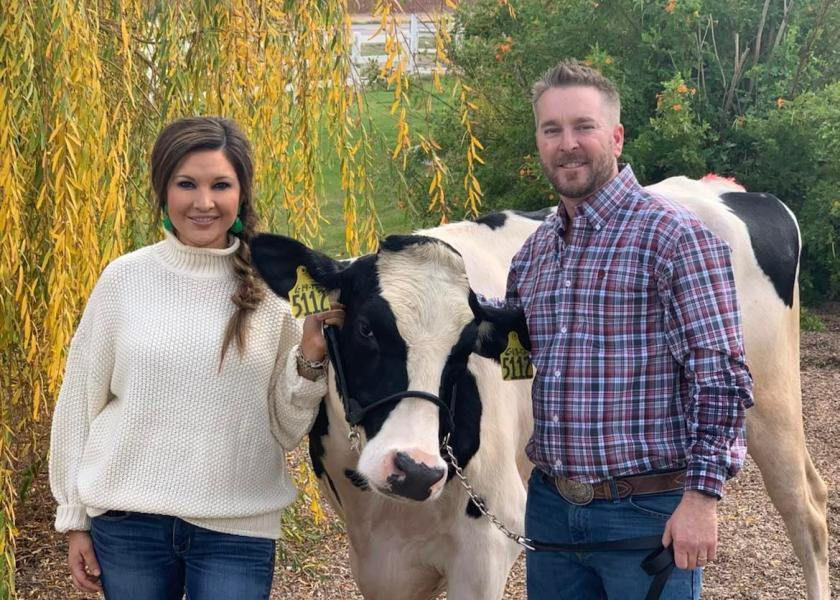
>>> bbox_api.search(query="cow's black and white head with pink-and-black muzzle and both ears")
[253,234,528,501]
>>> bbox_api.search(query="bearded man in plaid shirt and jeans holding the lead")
[507,61,752,600]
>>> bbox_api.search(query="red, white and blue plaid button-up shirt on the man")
[506,166,752,496]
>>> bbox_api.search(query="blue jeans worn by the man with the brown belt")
[525,469,702,600]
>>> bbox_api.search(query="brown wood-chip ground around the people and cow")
[16,304,840,600]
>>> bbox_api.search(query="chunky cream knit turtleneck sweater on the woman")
[50,235,326,539]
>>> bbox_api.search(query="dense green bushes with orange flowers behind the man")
[426,0,840,303]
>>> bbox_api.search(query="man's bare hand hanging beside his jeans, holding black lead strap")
[662,490,717,569]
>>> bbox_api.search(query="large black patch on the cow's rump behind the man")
[721,192,799,307]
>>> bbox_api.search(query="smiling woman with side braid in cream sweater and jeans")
[50,117,343,600]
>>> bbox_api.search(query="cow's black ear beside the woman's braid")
[251,233,343,298]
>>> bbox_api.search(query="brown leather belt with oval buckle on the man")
[540,469,685,506]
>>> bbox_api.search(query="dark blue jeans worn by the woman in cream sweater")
[90,511,274,600]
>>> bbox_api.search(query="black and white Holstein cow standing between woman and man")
[253,178,829,600]
